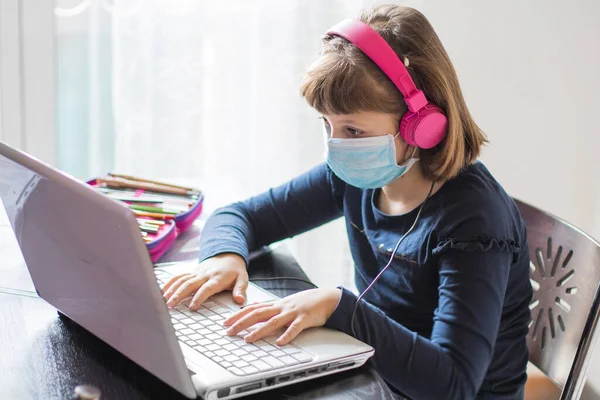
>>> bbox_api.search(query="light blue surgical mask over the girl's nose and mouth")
[326,135,419,189]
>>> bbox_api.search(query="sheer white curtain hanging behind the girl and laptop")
[57,0,426,287]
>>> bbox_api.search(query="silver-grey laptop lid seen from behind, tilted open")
[0,142,196,398]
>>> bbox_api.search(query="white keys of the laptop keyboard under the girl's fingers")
[155,271,313,376]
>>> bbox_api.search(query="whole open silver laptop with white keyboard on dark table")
[0,142,374,399]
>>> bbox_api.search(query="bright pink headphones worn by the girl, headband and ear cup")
[327,19,448,149]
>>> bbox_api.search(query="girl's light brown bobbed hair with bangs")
[301,5,487,180]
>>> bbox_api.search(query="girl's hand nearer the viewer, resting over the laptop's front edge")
[223,289,342,346]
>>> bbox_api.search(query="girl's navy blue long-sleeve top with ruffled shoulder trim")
[200,162,532,400]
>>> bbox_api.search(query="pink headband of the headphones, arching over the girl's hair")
[327,19,427,112]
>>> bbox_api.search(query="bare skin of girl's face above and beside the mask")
[322,111,412,164]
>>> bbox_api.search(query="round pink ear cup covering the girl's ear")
[400,104,448,149]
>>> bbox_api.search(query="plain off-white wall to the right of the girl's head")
[421,0,600,398]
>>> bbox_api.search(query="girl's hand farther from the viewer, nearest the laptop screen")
[162,253,248,310]
